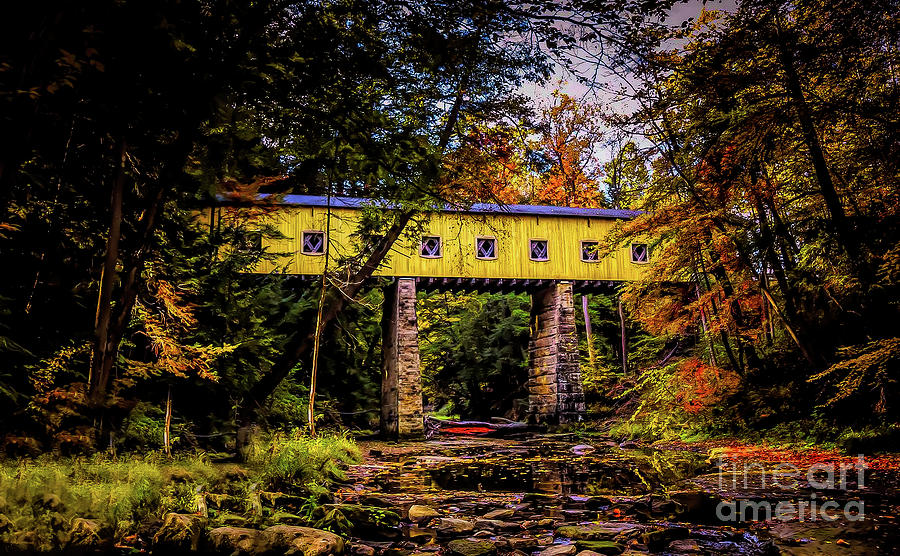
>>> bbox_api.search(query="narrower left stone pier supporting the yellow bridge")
[381,278,425,438]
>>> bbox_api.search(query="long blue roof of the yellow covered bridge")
[282,195,641,218]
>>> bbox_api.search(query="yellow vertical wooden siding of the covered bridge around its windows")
[256,207,644,281]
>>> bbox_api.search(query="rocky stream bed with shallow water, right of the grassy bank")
[330,436,900,556]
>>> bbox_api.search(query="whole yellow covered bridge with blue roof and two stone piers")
[241,195,650,437]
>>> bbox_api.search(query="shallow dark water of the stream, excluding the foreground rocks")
[343,435,900,554]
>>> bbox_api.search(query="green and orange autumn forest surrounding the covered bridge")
[0,0,900,453]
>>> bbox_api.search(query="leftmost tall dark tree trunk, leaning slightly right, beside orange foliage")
[88,138,126,403]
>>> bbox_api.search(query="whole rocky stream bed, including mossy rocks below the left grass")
[10,434,900,556]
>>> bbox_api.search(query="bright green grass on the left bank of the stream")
[0,432,360,550]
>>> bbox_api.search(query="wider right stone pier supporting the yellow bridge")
[528,282,584,425]
